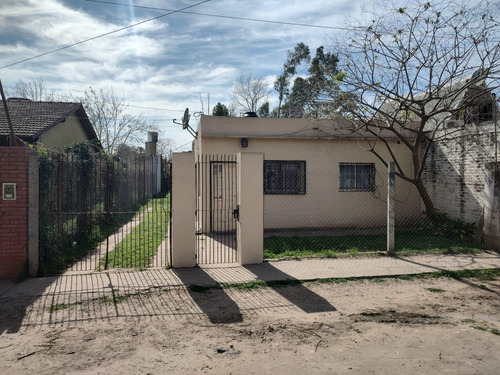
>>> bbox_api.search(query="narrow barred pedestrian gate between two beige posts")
[196,155,238,264]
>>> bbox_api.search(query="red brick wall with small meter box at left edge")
[0,147,31,279]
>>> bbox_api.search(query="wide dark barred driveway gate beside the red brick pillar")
[39,146,171,274]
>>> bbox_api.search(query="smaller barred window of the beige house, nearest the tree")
[339,163,375,191]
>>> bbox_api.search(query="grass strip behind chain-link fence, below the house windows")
[264,231,481,258]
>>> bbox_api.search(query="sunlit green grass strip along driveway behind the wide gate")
[97,194,170,270]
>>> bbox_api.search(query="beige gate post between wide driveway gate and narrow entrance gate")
[170,152,196,267]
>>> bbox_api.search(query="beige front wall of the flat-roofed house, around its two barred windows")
[195,137,421,229]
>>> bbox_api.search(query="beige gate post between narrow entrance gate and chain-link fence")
[237,152,264,265]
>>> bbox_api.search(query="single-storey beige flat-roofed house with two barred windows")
[193,115,421,231]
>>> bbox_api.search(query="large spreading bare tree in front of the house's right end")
[336,1,500,214]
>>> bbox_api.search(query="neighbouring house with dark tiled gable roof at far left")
[0,98,100,149]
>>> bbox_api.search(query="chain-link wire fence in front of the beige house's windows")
[264,167,480,258]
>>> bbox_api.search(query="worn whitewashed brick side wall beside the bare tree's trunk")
[423,122,495,223]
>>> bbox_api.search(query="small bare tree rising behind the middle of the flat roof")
[231,74,269,112]
